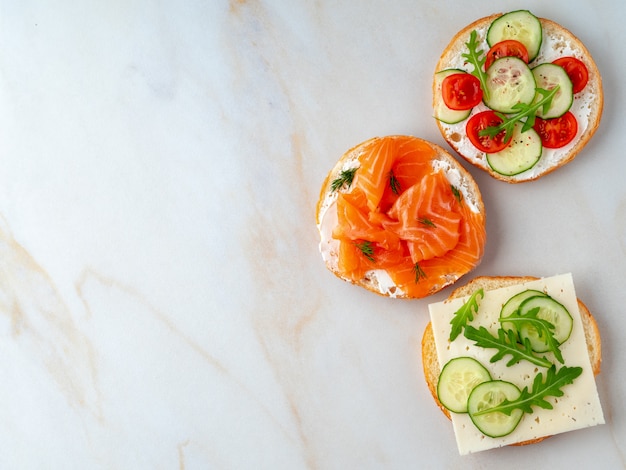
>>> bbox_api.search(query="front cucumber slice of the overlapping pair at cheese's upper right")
[519,296,574,352]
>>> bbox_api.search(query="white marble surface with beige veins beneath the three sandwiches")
[0,0,626,469]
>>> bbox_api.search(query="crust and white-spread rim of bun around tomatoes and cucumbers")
[433,13,604,183]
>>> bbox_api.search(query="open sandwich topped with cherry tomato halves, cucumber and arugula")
[433,10,604,183]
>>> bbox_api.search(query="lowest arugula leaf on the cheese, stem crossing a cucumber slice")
[475,365,583,416]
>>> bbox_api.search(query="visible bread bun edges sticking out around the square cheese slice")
[422,276,602,446]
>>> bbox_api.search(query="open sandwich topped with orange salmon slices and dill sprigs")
[316,136,486,298]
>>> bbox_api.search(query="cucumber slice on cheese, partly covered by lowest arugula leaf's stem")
[467,380,524,437]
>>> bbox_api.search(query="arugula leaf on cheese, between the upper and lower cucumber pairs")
[464,325,552,367]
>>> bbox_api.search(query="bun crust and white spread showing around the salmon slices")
[315,135,486,299]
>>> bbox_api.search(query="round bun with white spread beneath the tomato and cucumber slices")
[433,13,604,183]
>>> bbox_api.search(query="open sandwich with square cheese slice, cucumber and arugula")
[422,274,604,455]
